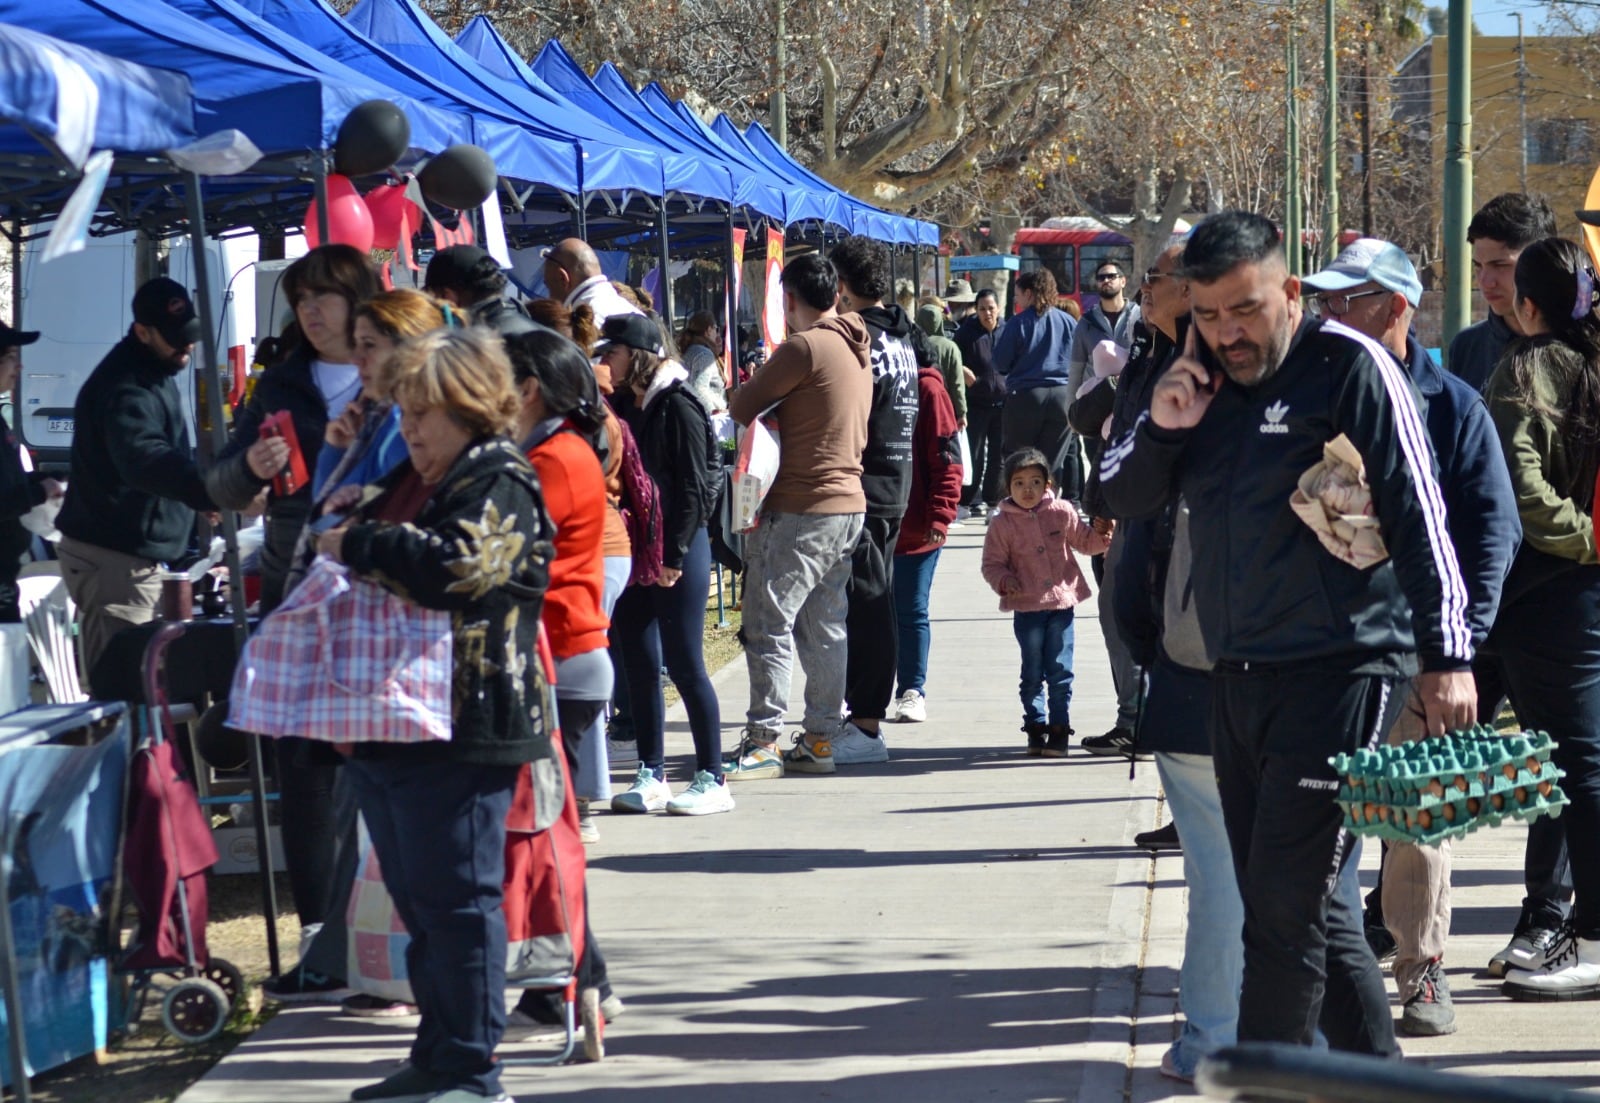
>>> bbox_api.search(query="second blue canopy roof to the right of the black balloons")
[346,0,664,195]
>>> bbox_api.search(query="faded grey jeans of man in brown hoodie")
[741,512,862,740]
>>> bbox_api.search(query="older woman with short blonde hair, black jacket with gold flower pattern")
[317,328,554,1103]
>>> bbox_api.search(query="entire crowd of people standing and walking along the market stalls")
[0,184,1600,1103]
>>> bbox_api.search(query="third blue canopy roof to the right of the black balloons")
[456,16,734,203]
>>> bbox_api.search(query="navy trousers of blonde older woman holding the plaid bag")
[344,748,522,1097]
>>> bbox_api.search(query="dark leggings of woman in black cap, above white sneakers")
[611,528,722,776]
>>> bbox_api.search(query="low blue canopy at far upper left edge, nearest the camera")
[0,26,195,154]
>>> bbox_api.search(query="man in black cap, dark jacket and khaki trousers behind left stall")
[56,277,278,669]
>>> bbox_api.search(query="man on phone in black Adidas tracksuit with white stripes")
[1101,211,1477,1057]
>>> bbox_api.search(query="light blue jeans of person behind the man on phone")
[1155,751,1245,1076]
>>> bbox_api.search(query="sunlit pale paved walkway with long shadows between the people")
[181,523,1600,1103]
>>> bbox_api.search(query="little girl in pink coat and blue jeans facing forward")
[984,448,1114,759]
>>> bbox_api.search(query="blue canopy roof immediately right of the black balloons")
[240,0,582,194]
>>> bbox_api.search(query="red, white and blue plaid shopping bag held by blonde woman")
[229,557,453,743]
